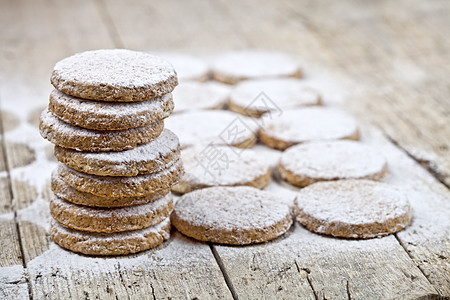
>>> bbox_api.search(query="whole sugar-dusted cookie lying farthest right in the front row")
[295,179,412,239]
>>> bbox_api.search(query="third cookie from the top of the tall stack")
[39,110,164,152]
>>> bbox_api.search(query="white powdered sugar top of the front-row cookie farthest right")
[297,180,411,225]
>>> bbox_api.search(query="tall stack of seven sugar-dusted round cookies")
[40,49,183,255]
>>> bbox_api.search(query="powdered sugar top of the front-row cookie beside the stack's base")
[175,186,290,232]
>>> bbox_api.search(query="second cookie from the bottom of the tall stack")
[50,194,173,233]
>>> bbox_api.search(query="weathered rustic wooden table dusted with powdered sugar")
[0,0,450,299]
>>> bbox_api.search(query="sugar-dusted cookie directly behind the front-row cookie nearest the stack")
[172,145,271,194]
